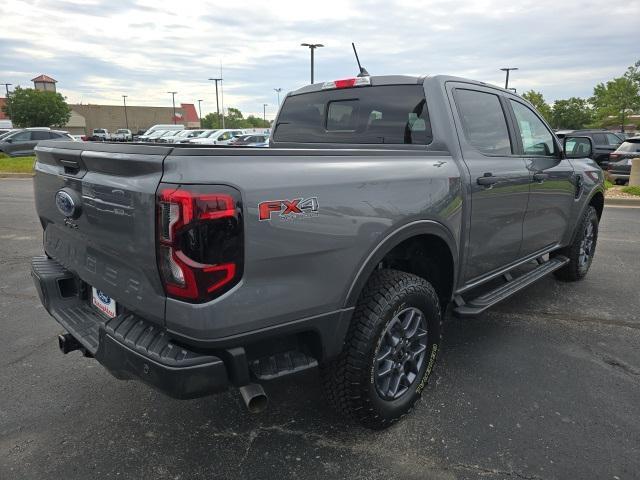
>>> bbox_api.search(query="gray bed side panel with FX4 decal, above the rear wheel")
[162,148,462,339]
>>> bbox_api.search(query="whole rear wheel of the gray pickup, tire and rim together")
[321,270,442,429]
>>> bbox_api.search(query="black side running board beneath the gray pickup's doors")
[453,255,569,317]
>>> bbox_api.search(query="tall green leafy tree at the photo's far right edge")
[590,75,640,131]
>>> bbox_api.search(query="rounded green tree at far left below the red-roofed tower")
[3,87,71,128]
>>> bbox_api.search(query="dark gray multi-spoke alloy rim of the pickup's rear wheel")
[374,307,427,400]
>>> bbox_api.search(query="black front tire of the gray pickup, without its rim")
[554,205,598,282]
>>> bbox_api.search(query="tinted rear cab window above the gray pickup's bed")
[273,85,433,145]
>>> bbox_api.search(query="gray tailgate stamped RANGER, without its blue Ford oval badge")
[34,142,170,324]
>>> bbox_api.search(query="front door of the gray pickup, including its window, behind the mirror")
[509,99,576,256]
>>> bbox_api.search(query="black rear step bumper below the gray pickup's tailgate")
[31,256,230,398]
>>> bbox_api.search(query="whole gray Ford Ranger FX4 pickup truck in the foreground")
[32,76,604,428]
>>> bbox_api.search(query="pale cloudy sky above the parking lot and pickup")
[0,0,640,118]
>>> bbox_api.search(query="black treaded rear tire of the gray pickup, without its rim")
[320,270,442,430]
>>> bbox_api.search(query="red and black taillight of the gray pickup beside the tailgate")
[157,184,244,303]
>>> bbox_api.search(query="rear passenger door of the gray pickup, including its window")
[449,84,530,282]
